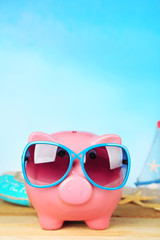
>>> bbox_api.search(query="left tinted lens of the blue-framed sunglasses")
[25,144,70,186]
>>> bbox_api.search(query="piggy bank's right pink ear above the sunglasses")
[93,134,121,144]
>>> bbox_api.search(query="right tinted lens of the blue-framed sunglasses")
[84,146,128,188]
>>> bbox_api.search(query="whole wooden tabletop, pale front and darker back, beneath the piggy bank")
[0,200,160,240]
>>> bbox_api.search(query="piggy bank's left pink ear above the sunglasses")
[28,132,55,142]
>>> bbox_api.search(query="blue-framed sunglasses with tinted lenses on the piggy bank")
[22,141,130,190]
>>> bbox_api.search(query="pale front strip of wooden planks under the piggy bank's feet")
[0,216,160,239]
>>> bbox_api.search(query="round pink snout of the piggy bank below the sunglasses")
[58,176,93,205]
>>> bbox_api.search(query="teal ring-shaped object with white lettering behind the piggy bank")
[0,174,30,206]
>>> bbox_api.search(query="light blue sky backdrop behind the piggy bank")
[0,0,160,185]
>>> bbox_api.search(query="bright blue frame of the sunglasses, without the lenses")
[21,141,131,190]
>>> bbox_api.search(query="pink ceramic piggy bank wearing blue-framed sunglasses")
[22,131,130,230]
